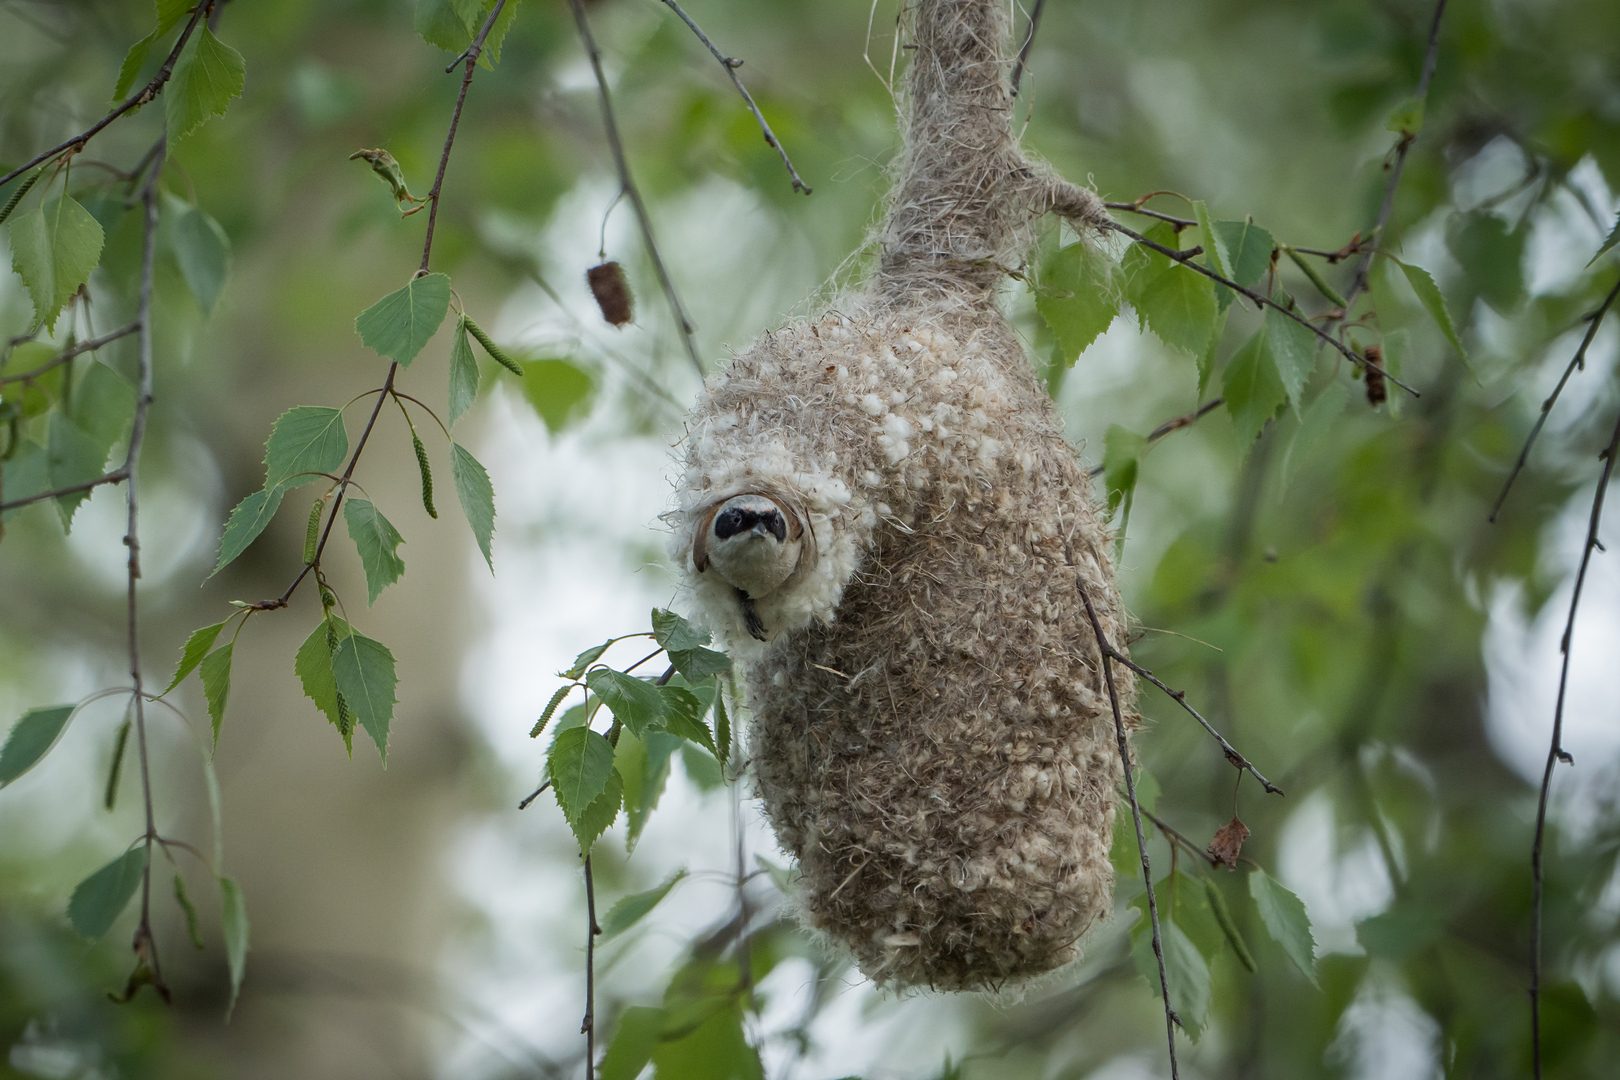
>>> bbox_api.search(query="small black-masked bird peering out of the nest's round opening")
[692,491,805,641]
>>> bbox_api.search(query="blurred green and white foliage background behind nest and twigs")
[0,0,1620,1080]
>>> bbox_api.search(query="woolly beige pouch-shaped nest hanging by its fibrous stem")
[672,0,1131,989]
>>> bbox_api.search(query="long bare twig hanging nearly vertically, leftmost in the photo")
[123,141,166,1001]
